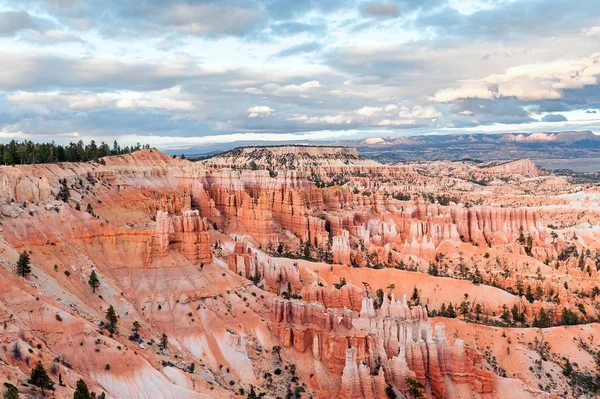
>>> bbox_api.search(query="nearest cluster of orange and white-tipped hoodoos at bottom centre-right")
[270,296,494,398]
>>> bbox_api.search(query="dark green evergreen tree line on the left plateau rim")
[0,140,150,165]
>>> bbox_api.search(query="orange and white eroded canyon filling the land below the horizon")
[0,146,600,399]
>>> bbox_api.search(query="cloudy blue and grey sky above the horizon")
[0,0,600,148]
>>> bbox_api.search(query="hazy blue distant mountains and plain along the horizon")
[164,131,600,172]
